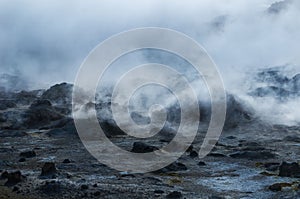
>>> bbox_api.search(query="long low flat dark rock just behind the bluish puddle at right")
[229,151,276,160]
